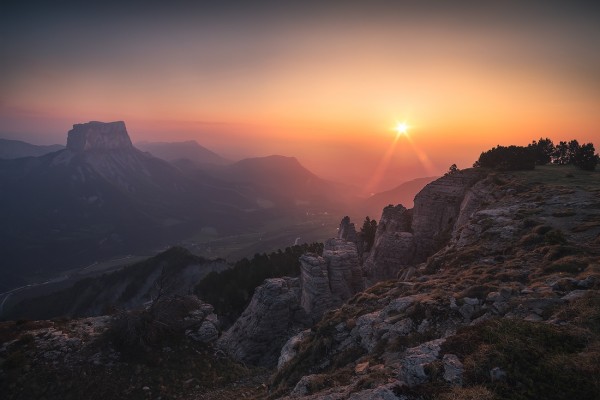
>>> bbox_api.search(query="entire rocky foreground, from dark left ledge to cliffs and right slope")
[0,166,600,400]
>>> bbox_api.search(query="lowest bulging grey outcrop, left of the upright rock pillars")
[218,277,311,367]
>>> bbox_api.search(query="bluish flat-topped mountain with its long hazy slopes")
[0,122,264,286]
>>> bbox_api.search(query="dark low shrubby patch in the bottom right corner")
[442,307,600,399]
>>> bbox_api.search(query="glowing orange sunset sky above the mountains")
[0,1,600,188]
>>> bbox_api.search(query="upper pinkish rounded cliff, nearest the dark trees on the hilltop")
[363,170,482,283]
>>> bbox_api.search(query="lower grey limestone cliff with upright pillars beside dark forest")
[219,239,363,367]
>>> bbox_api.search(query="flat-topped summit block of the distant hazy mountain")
[67,121,133,153]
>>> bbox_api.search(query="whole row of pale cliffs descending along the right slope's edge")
[221,170,482,365]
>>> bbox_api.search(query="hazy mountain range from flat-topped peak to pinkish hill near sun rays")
[0,121,352,292]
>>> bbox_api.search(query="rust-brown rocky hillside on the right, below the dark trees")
[273,167,600,399]
